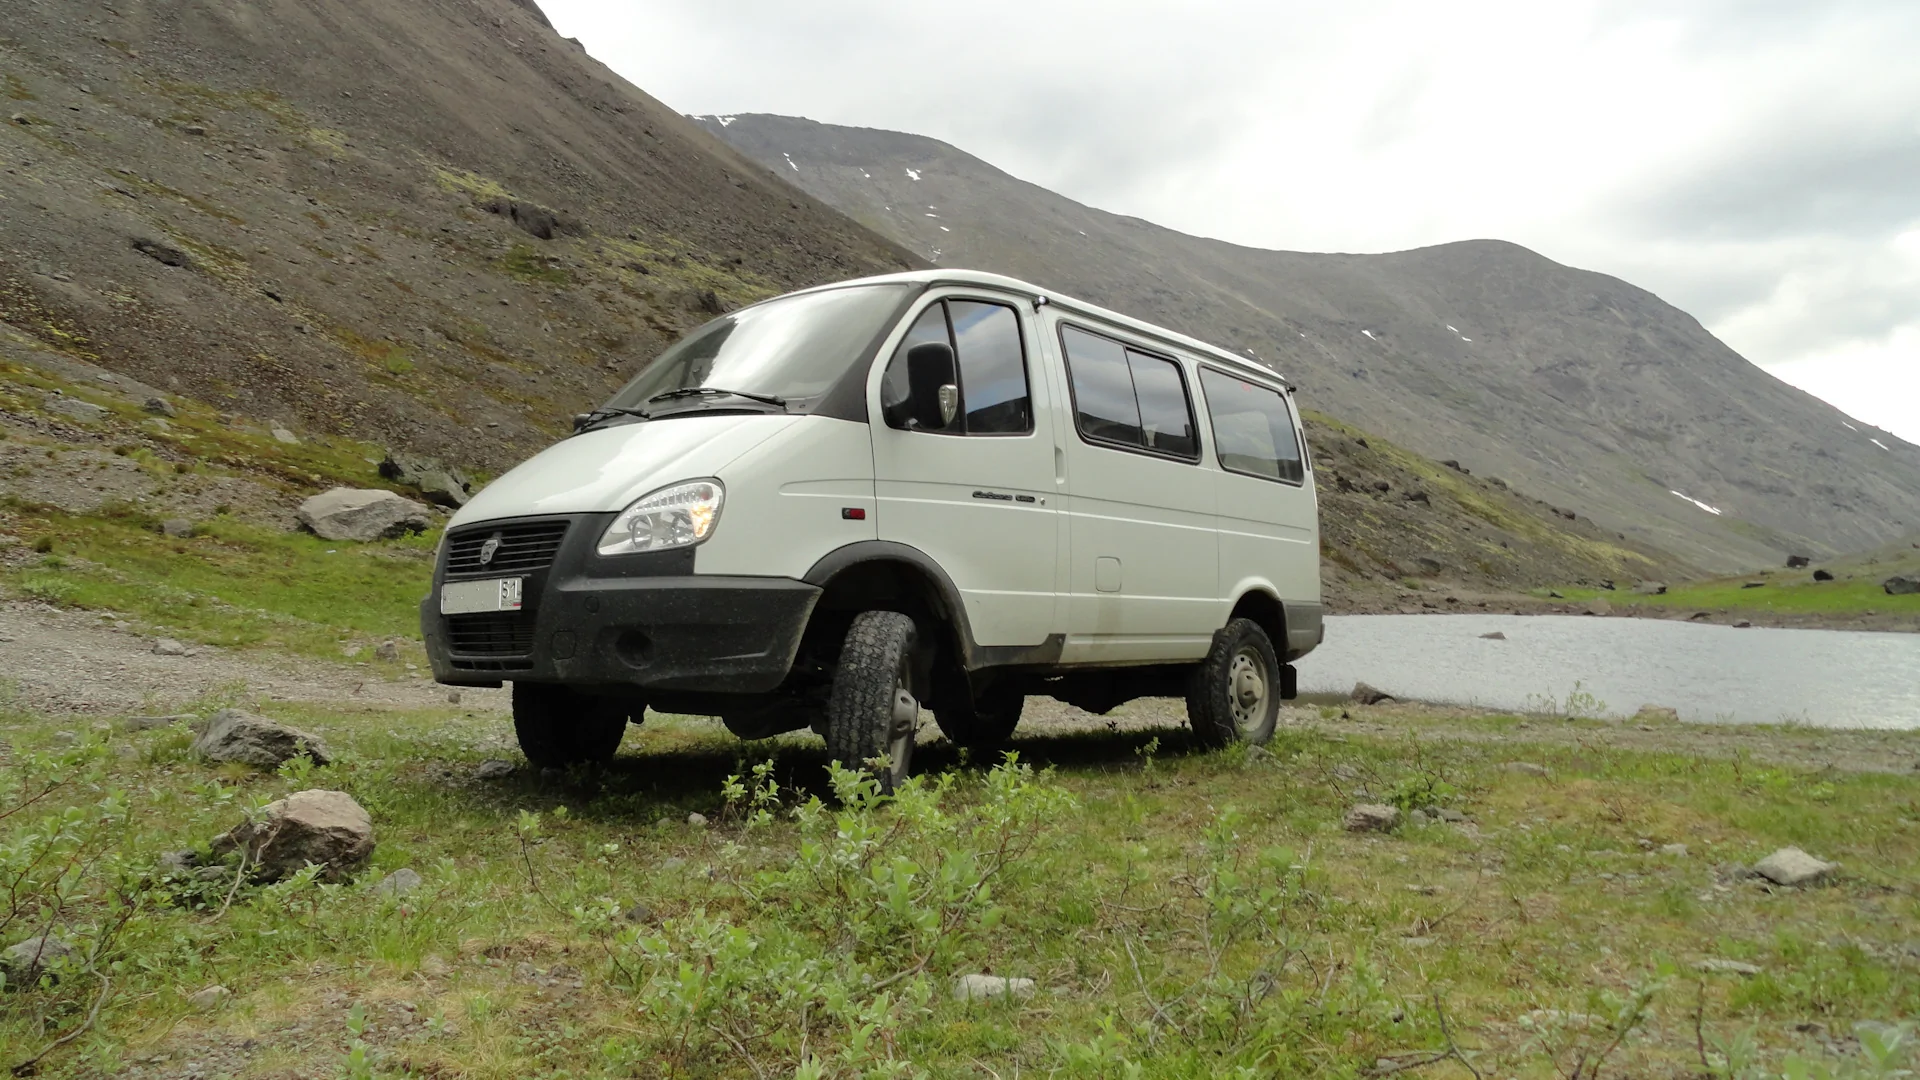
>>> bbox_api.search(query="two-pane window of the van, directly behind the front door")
[1060,323,1200,459]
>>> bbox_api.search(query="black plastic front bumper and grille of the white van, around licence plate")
[420,513,820,694]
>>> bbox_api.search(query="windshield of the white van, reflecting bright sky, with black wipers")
[603,284,906,415]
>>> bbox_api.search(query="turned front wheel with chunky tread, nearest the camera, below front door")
[828,611,920,792]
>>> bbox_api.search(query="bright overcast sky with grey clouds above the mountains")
[541,0,1920,442]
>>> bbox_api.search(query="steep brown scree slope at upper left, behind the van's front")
[0,0,920,469]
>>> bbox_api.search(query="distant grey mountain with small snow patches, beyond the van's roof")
[695,113,1920,567]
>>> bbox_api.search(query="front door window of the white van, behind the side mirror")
[879,300,1033,434]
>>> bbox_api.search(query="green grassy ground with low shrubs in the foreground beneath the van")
[0,701,1920,1078]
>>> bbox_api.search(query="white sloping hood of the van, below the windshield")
[447,413,806,528]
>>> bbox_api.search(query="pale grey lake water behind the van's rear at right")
[1298,615,1920,728]
